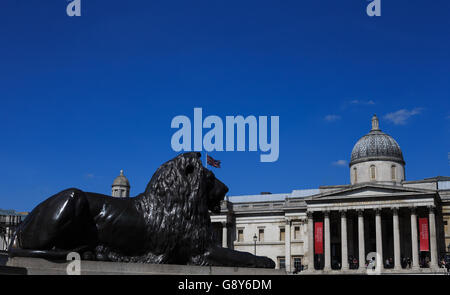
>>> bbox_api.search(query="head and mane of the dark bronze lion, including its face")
[138,152,228,262]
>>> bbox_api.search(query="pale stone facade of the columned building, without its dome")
[211,178,450,272]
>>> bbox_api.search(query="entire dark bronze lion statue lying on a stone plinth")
[9,152,275,268]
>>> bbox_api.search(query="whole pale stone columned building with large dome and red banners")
[211,116,450,273]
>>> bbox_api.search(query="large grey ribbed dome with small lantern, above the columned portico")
[350,115,405,166]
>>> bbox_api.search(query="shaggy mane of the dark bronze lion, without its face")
[97,153,213,264]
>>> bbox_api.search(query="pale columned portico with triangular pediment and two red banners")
[305,184,440,272]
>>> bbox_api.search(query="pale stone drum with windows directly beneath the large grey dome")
[350,161,405,184]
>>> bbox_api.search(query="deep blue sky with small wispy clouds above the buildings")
[0,0,450,211]
